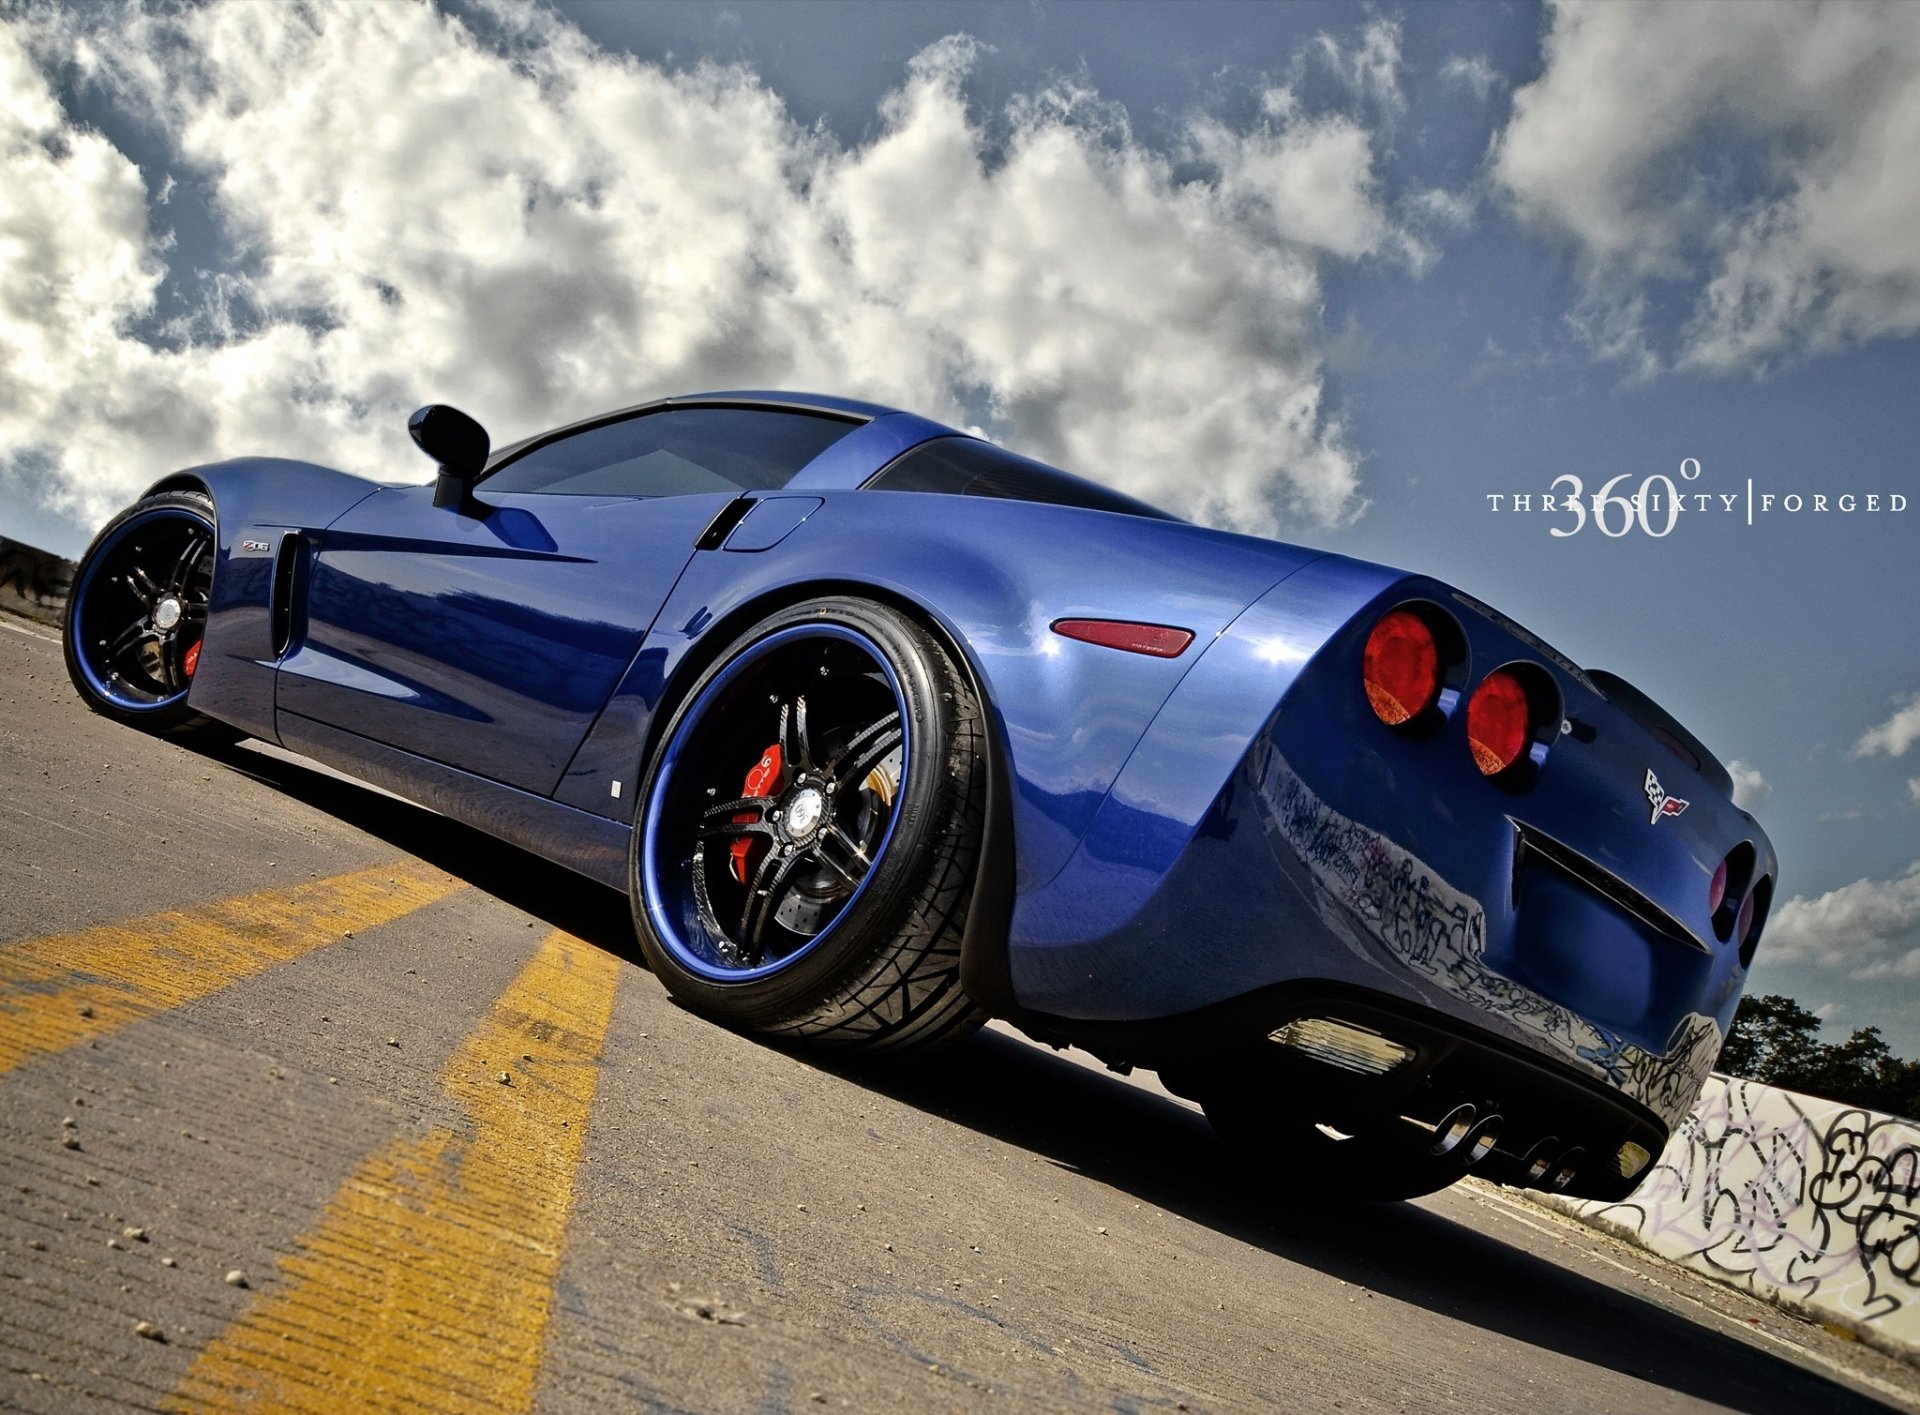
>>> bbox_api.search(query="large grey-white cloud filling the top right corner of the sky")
[1492,0,1920,371]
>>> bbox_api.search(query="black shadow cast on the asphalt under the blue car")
[211,747,1880,1415]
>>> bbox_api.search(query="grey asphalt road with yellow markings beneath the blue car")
[0,620,1920,1415]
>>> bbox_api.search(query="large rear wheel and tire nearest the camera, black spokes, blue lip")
[628,599,987,1054]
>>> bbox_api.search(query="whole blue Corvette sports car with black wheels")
[65,394,1778,1198]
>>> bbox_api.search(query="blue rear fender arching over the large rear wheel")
[557,492,1315,889]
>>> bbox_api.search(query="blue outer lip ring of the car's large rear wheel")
[639,624,914,983]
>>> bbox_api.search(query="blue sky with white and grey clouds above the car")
[0,0,1920,1056]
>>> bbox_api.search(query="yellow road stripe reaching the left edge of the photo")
[0,860,461,1075]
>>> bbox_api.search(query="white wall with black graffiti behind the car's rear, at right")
[1548,1075,1920,1359]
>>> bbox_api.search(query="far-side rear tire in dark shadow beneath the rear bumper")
[1202,1091,1490,1202]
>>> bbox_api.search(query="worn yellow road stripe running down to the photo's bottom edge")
[169,931,620,1411]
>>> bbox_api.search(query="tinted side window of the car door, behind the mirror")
[484,407,860,495]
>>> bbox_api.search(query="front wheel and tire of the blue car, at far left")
[61,492,242,745]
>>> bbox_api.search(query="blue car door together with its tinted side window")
[275,405,858,795]
